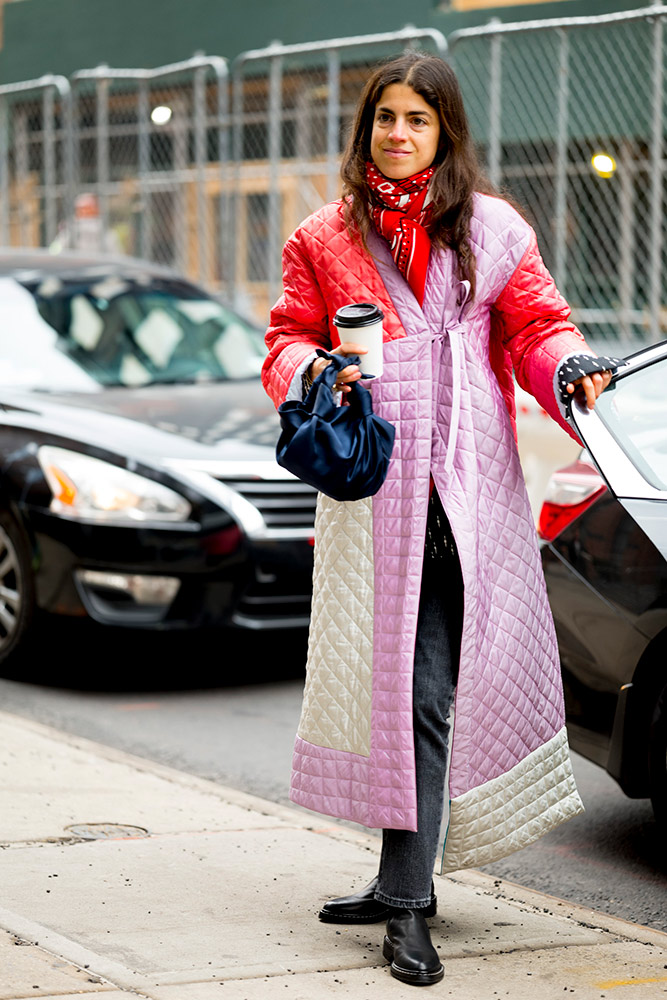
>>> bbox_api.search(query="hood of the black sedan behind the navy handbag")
[0,379,280,464]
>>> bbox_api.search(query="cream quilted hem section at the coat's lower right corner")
[441,729,584,873]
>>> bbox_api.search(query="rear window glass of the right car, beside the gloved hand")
[596,358,667,490]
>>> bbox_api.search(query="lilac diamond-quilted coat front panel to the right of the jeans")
[414,224,563,797]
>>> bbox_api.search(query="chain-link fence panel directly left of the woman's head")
[233,28,447,315]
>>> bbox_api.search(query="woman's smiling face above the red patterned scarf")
[371,83,440,181]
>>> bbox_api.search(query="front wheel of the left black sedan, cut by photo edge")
[0,511,35,666]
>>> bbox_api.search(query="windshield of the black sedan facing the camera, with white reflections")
[0,274,265,392]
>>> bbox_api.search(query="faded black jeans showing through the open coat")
[375,490,463,909]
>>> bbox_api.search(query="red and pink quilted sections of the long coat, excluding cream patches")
[263,196,585,844]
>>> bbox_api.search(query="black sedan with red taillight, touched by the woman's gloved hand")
[539,343,667,831]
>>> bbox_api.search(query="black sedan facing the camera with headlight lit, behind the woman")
[0,251,316,661]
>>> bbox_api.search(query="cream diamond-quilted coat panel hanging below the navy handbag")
[298,493,373,757]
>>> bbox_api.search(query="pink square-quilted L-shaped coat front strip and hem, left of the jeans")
[291,337,431,830]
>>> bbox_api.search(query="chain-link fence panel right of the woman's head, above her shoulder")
[449,6,667,348]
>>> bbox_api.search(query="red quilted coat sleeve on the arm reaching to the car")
[491,230,593,440]
